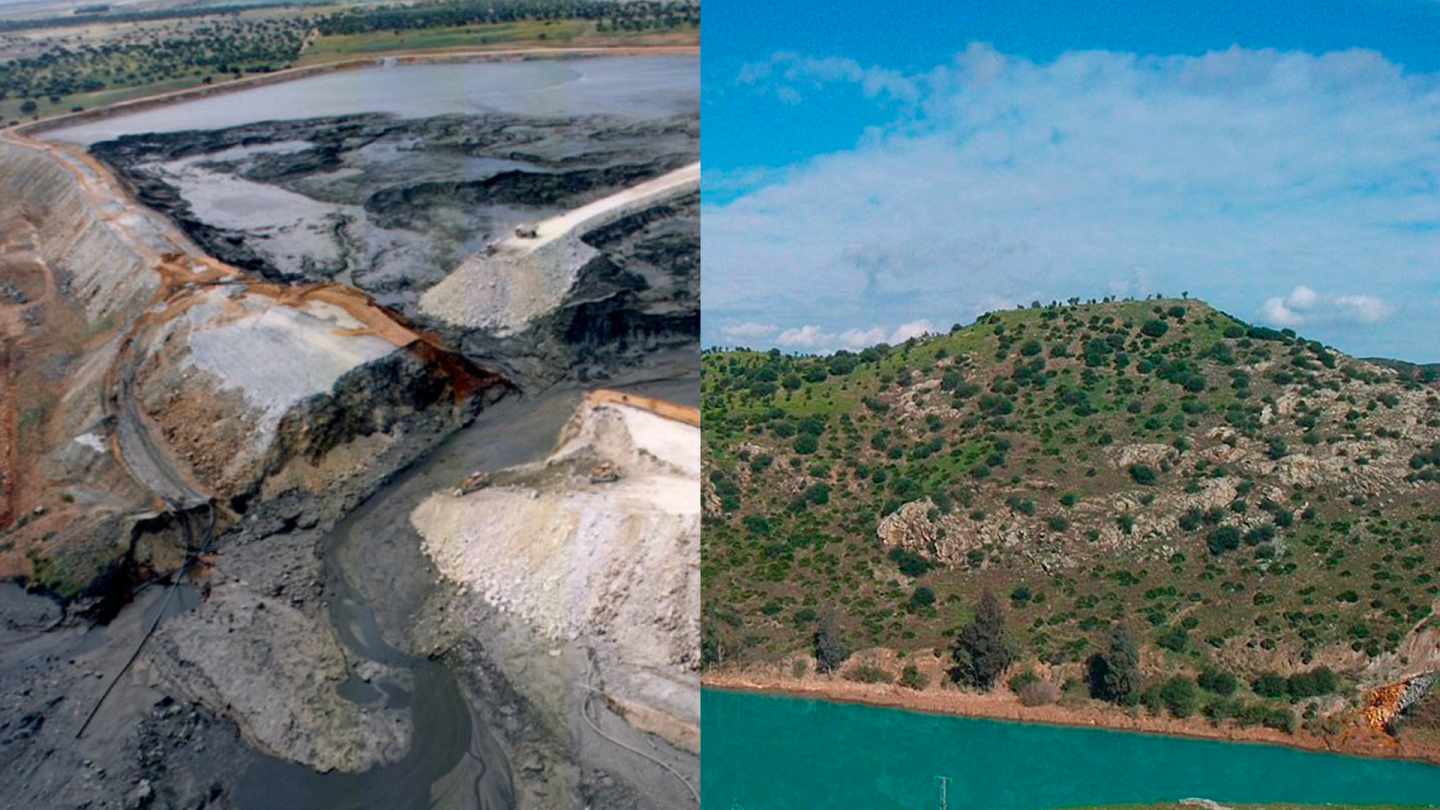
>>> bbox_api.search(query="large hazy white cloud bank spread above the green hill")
[701,45,1440,353]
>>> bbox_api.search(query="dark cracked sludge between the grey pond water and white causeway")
[92,112,698,314]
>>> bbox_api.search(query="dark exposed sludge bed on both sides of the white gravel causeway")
[92,114,700,388]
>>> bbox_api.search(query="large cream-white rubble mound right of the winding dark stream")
[410,394,700,675]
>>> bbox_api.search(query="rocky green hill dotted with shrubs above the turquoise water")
[703,300,1440,731]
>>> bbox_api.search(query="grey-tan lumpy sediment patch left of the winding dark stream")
[148,584,412,773]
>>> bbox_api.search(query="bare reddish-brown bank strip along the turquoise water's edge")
[701,670,1440,765]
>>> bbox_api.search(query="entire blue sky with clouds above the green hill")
[701,0,1440,360]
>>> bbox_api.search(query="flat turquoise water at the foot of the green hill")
[701,689,1440,810]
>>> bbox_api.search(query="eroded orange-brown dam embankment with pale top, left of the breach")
[0,126,505,608]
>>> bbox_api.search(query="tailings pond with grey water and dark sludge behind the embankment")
[43,56,700,375]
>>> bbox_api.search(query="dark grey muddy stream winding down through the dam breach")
[236,378,679,810]
